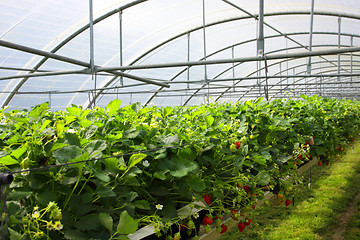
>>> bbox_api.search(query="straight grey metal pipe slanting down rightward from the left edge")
[0,39,170,87]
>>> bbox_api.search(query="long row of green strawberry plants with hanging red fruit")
[0,96,360,239]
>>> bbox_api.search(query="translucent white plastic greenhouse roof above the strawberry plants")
[0,0,360,110]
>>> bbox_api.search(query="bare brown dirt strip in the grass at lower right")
[331,174,360,240]
